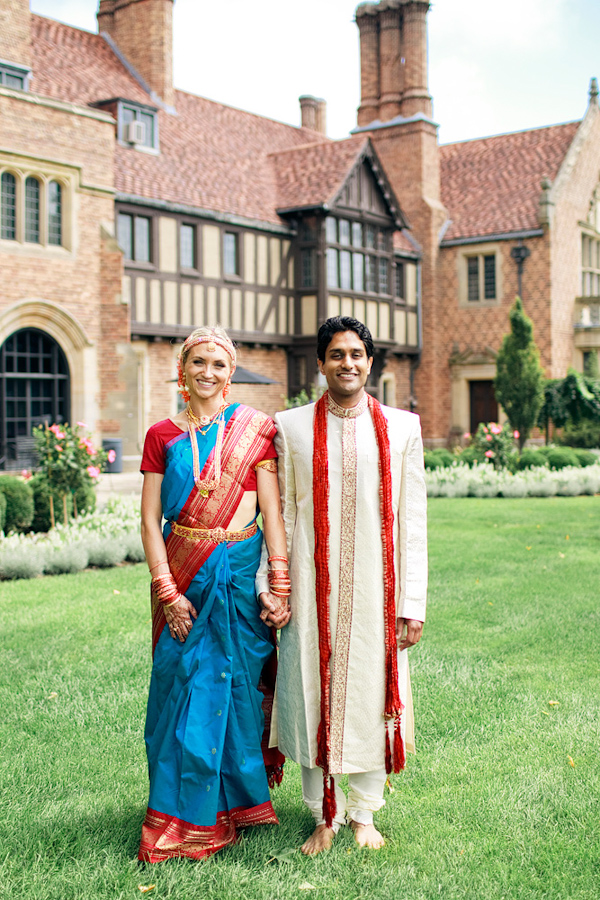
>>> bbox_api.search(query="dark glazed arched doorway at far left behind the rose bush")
[0,328,70,469]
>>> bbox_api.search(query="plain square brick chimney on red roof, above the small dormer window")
[97,0,175,106]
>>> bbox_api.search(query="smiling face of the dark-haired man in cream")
[319,331,373,406]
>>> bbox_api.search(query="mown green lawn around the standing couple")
[0,497,600,900]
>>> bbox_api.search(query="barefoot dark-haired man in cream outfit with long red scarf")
[257,316,427,855]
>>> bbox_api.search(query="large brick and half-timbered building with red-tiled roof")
[0,0,600,468]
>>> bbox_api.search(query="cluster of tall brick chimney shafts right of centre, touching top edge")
[356,0,431,127]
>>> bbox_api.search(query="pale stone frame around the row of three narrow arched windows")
[0,159,75,253]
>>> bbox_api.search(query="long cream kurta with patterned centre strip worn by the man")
[257,404,427,773]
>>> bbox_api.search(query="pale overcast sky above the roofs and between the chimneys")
[31,0,600,143]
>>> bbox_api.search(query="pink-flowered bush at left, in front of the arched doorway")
[33,422,114,525]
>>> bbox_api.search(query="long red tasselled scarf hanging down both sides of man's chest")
[313,393,405,828]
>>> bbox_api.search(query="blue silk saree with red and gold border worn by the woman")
[139,404,283,862]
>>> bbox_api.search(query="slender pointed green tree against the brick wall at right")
[494,297,545,450]
